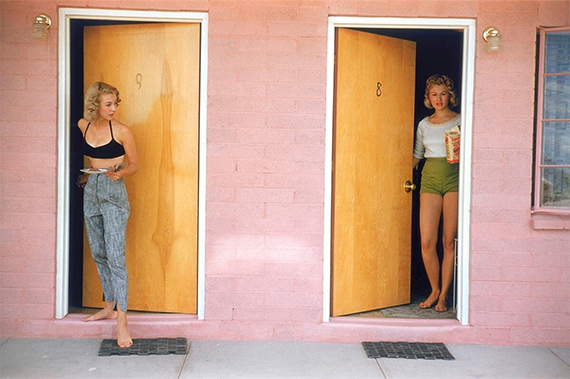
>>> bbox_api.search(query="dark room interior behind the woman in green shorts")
[352,28,463,314]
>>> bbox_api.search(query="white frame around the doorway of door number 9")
[55,8,208,320]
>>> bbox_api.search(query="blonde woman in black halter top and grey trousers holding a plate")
[78,82,138,347]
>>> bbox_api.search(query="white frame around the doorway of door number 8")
[323,17,476,325]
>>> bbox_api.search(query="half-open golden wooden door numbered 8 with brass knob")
[331,29,416,316]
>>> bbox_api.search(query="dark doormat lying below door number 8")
[362,342,455,360]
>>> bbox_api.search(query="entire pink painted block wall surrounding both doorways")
[0,0,570,345]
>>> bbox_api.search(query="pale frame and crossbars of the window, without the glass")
[532,26,570,215]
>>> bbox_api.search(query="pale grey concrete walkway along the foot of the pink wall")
[0,338,570,379]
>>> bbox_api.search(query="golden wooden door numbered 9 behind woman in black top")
[83,23,200,313]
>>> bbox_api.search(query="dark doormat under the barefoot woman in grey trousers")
[99,338,188,357]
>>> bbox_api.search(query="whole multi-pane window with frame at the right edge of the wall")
[534,27,570,213]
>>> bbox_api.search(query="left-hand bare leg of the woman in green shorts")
[420,193,443,308]
